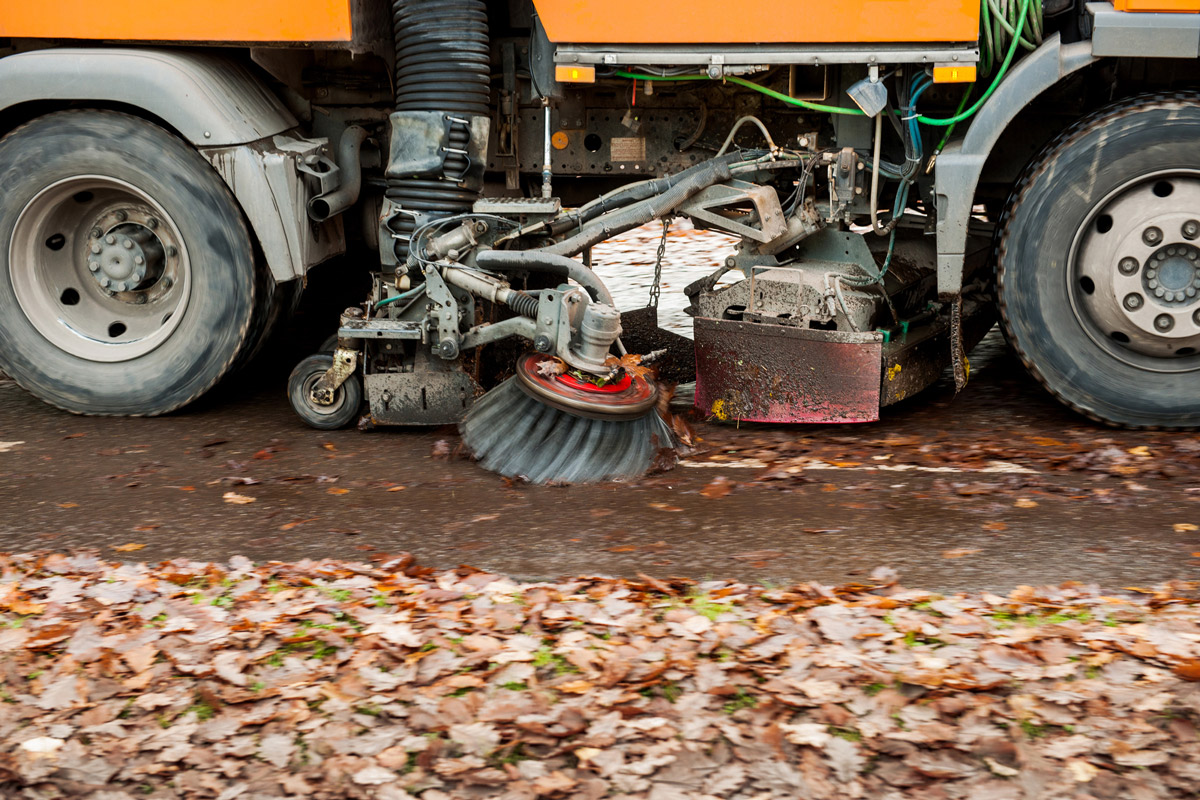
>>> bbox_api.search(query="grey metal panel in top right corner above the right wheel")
[1087,2,1200,59]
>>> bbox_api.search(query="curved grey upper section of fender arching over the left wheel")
[0,48,296,146]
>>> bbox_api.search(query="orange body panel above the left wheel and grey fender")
[0,0,352,42]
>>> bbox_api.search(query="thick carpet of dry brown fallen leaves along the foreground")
[0,554,1200,800]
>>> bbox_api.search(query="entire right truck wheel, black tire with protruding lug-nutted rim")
[996,92,1200,428]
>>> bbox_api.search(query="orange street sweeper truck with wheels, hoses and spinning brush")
[0,0,1200,482]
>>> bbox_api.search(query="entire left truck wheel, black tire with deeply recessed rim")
[0,110,256,415]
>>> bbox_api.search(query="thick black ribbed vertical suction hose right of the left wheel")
[386,0,491,261]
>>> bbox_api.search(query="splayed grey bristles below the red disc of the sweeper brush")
[458,378,674,483]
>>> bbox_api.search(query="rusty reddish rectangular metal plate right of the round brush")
[695,317,883,422]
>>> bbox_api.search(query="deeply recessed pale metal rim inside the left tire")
[8,175,192,362]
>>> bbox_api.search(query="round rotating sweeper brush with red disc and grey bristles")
[460,353,674,483]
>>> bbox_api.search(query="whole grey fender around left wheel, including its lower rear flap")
[0,48,344,281]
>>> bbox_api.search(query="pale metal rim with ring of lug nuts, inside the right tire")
[1063,170,1200,373]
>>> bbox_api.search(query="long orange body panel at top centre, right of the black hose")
[534,0,979,44]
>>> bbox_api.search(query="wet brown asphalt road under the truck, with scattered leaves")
[0,227,1200,590]
